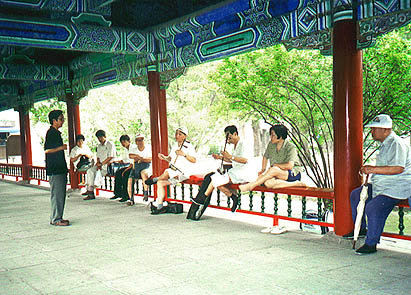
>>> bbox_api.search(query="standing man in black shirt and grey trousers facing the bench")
[44,110,70,226]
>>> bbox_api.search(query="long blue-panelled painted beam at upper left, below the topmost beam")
[0,17,154,54]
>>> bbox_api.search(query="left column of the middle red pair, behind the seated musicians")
[147,71,161,191]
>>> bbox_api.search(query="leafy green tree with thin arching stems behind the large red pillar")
[210,27,411,187]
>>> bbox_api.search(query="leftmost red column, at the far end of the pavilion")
[18,106,33,180]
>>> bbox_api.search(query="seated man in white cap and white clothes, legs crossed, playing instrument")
[145,127,197,214]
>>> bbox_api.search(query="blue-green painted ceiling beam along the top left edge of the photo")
[0,0,111,16]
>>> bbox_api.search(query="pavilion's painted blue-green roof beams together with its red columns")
[0,0,411,235]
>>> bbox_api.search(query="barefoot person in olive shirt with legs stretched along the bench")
[239,124,305,192]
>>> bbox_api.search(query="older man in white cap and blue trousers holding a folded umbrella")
[344,115,411,255]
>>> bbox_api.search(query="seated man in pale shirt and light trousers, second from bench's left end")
[83,130,116,200]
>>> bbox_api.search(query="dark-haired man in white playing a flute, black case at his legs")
[191,125,257,212]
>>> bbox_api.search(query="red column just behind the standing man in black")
[66,94,81,189]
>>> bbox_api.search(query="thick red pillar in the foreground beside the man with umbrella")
[333,20,363,235]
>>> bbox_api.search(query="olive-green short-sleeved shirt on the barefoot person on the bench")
[264,140,303,173]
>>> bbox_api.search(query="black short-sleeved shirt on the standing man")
[44,126,68,175]
